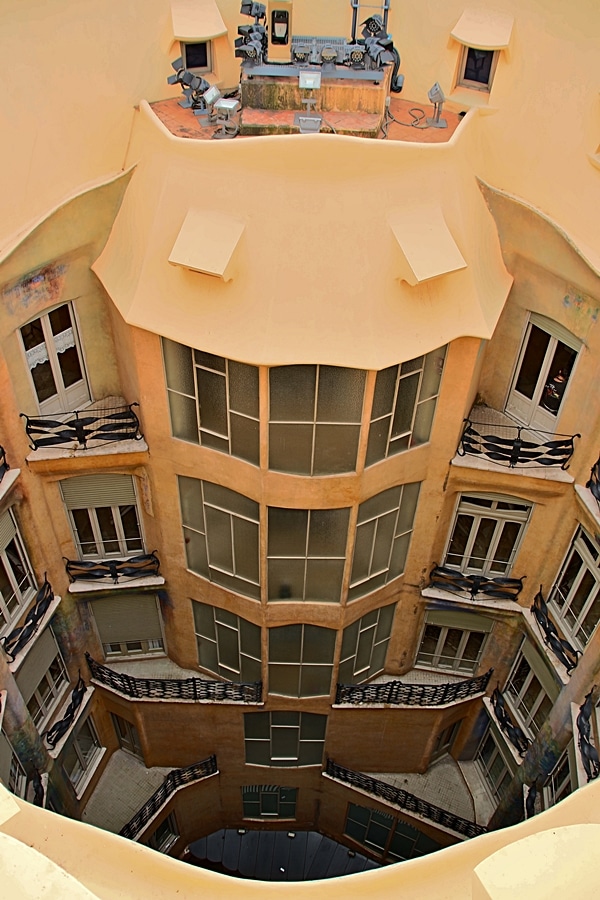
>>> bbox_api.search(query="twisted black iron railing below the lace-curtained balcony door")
[21,403,142,450]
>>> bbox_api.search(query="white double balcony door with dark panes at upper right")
[506,313,581,432]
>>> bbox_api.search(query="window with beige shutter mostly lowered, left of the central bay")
[90,591,165,659]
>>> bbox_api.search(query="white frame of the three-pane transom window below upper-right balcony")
[444,491,534,578]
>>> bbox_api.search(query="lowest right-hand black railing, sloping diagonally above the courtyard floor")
[325,759,487,838]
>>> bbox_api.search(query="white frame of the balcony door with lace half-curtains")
[19,301,92,415]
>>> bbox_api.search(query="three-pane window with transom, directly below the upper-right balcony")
[445,494,531,578]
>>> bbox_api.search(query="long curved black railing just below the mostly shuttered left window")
[85,653,262,703]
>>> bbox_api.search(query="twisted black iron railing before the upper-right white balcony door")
[457,419,581,469]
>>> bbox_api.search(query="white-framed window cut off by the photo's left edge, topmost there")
[0,512,35,635]
